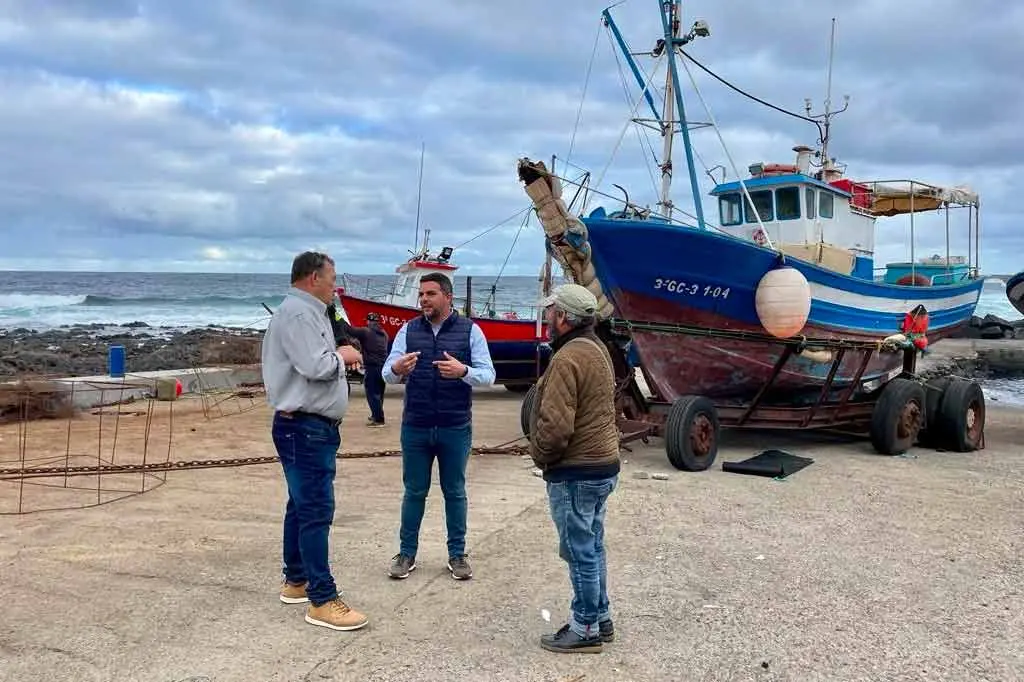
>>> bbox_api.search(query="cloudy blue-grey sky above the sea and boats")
[0,0,1024,273]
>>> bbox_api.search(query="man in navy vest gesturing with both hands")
[383,272,495,581]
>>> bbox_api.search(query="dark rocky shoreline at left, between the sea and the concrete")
[0,323,263,378]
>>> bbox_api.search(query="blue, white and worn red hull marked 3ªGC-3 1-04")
[584,218,982,403]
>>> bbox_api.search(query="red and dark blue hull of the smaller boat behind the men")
[339,294,551,384]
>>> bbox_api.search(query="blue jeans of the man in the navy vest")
[398,423,473,558]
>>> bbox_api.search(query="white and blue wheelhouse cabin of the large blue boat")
[711,146,874,281]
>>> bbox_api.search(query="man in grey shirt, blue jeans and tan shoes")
[261,251,368,630]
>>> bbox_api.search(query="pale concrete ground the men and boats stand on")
[0,378,1024,682]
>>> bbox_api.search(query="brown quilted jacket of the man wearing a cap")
[529,323,620,481]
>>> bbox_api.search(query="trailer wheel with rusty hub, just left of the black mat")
[665,395,720,471]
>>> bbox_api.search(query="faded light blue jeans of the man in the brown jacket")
[548,475,618,637]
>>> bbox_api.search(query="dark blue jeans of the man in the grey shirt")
[271,414,341,606]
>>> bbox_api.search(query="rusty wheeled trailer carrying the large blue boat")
[520,319,985,471]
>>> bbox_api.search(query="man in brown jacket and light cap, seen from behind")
[529,284,620,652]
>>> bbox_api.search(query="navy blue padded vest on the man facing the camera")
[401,310,473,428]
